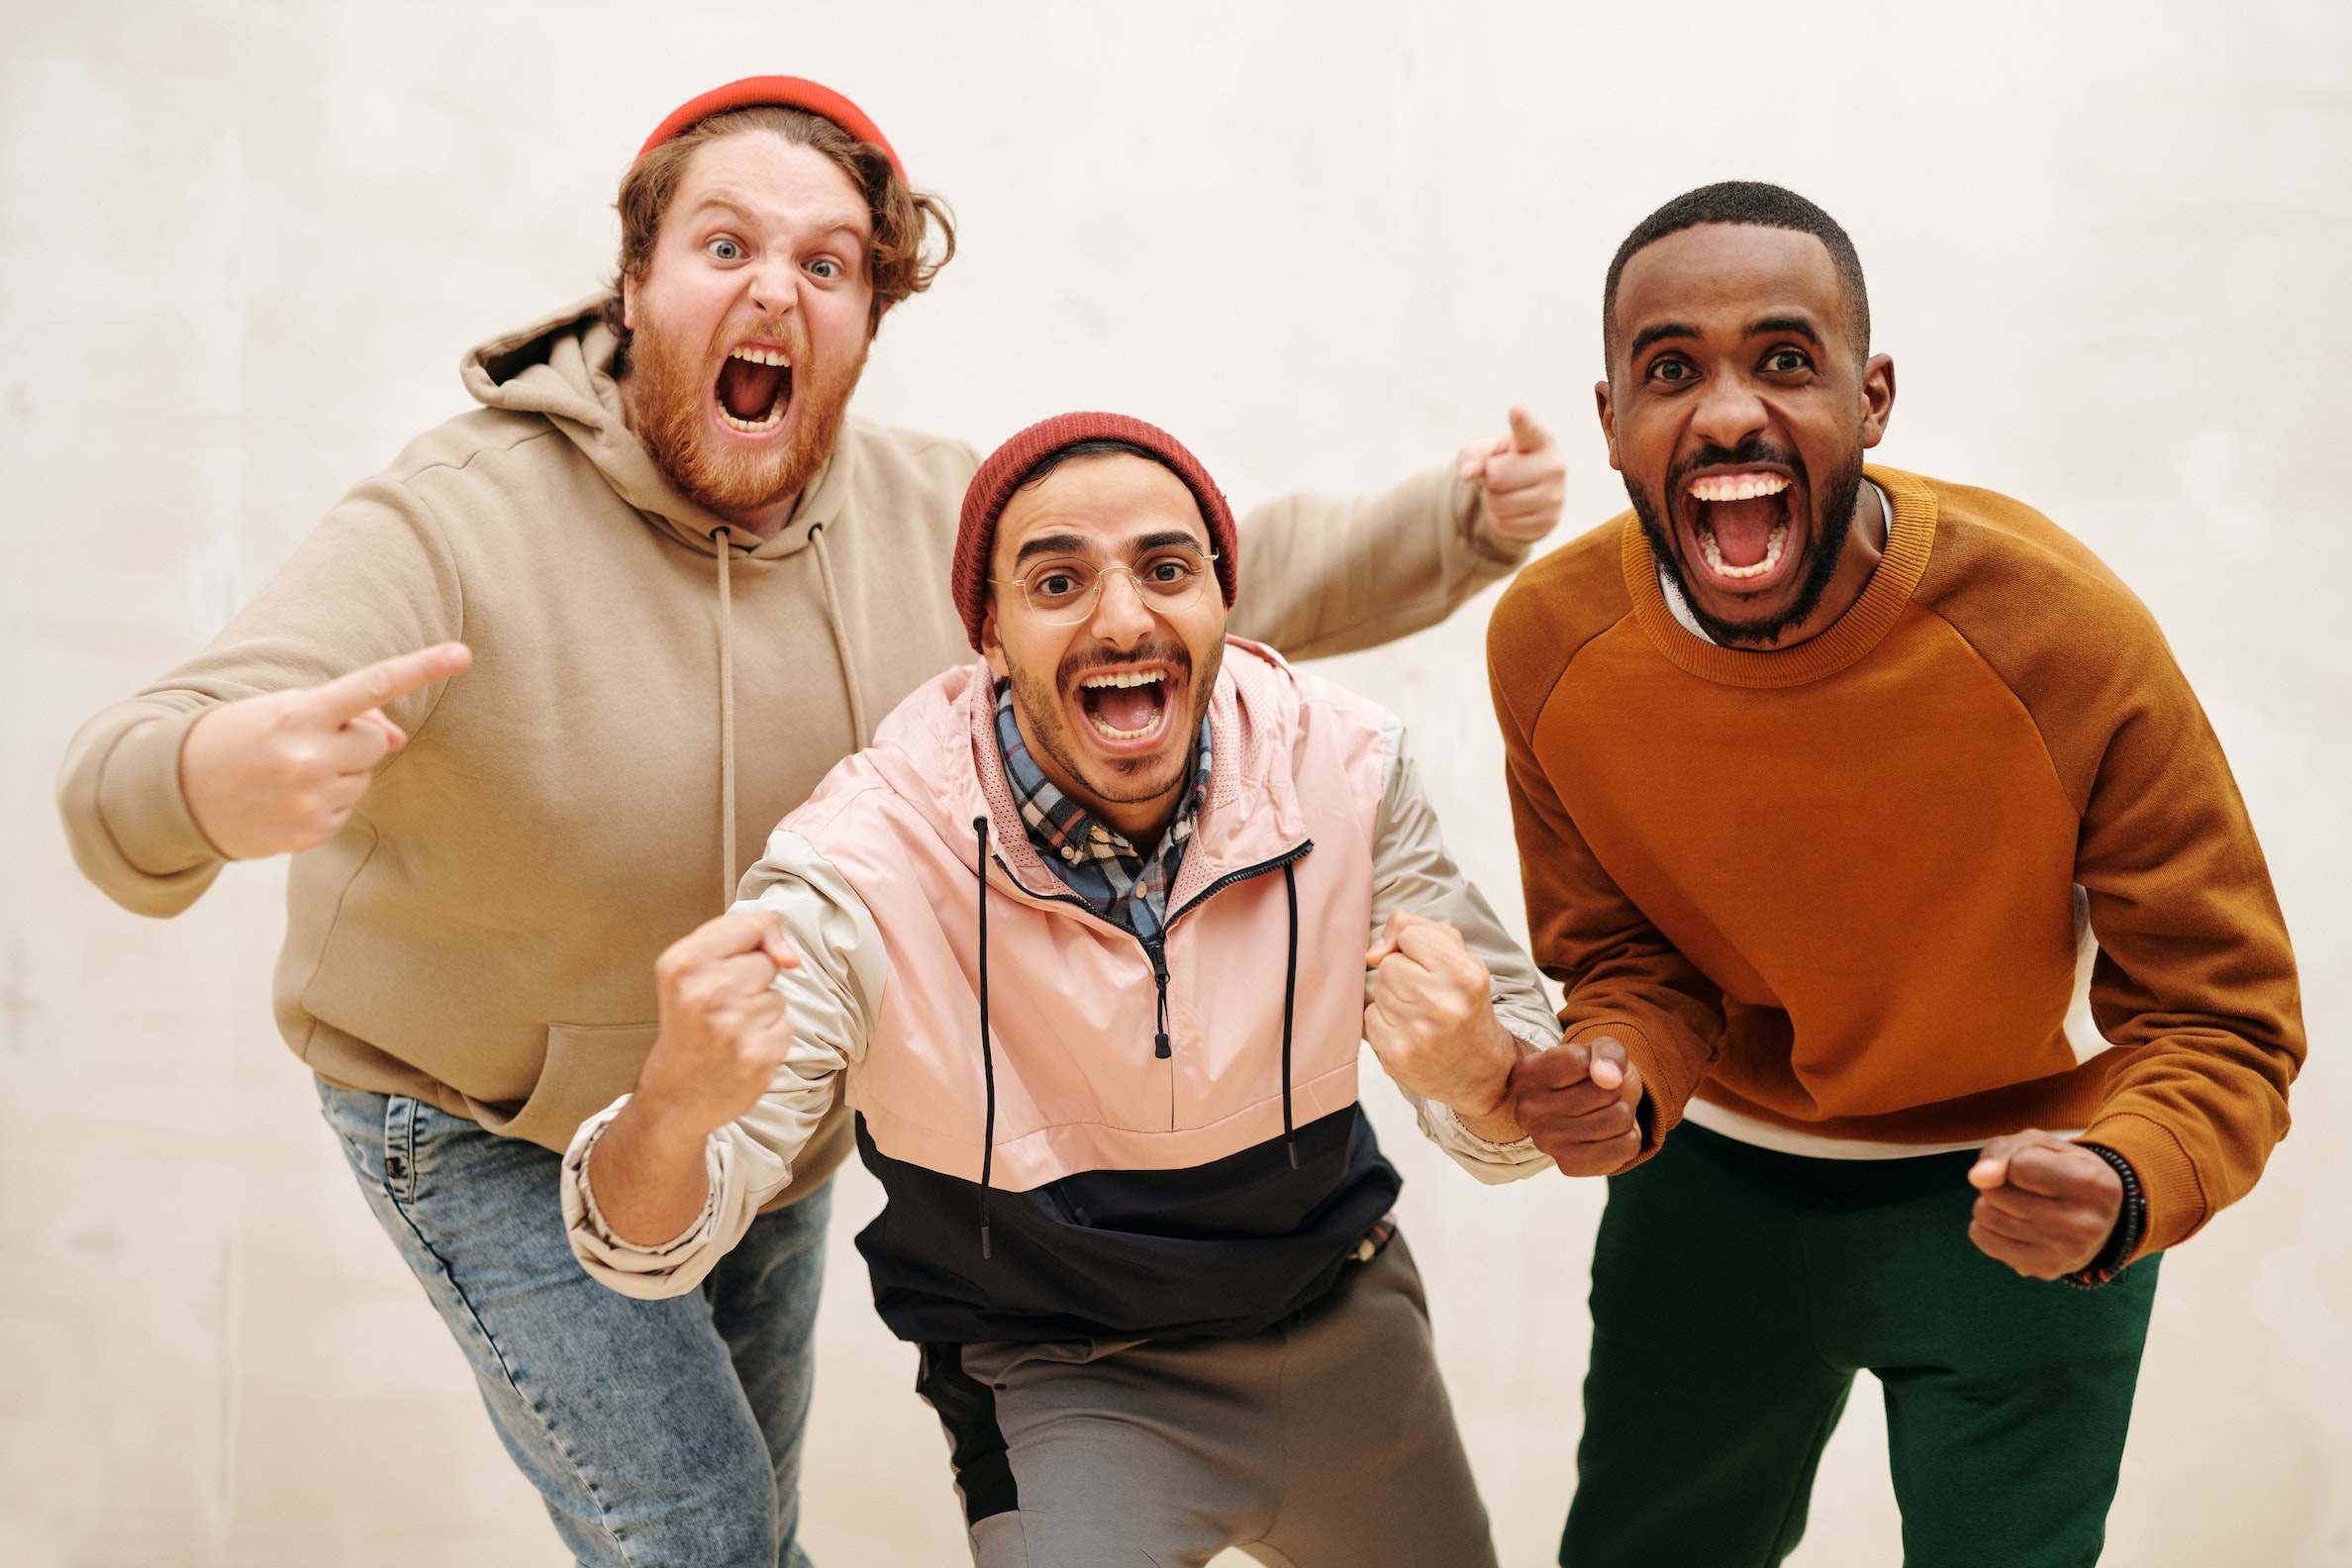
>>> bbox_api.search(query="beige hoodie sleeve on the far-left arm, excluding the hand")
[56,477,465,917]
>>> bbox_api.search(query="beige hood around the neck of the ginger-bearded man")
[458,291,846,559]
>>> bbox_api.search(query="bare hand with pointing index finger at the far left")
[179,641,473,860]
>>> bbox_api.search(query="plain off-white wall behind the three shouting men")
[0,0,2352,1568]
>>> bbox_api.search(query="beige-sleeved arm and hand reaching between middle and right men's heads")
[1230,409,1566,658]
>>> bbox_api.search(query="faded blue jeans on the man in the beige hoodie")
[318,1081,833,1568]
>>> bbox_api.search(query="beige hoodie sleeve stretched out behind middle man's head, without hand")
[1227,468,1528,658]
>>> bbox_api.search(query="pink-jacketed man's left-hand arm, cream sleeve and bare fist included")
[562,830,889,1298]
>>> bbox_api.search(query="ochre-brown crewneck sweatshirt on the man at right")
[1487,468,2303,1250]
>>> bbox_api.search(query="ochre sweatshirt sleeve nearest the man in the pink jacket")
[1489,653,1724,1159]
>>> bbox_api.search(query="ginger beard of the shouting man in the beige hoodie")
[628,315,872,517]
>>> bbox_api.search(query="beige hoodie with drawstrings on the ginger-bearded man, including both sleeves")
[58,299,1521,1199]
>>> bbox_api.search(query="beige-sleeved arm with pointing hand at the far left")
[56,479,470,917]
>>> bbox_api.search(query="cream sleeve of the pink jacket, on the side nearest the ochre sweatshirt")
[1366,715,1559,1183]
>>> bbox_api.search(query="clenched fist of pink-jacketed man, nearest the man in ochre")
[1364,910,1524,1142]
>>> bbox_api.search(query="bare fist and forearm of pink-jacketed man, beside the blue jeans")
[588,910,800,1246]
